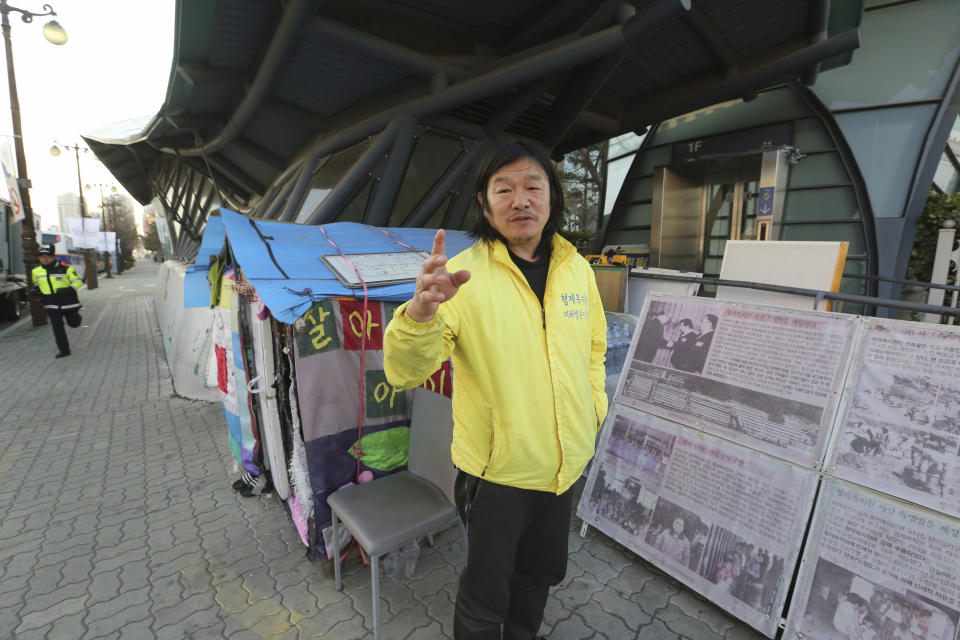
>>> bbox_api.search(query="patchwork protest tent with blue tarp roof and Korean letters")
[202,209,473,559]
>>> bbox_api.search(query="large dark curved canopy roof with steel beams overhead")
[84,0,862,206]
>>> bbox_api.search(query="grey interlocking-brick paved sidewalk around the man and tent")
[0,262,762,640]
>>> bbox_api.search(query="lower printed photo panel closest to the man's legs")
[577,404,816,637]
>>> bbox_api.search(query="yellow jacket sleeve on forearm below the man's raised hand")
[383,301,457,389]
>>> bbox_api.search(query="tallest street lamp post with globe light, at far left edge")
[0,0,67,326]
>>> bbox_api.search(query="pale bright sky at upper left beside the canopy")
[0,0,174,228]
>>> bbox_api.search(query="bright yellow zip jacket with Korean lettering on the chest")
[383,235,607,494]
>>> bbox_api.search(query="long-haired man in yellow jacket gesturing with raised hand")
[383,141,607,640]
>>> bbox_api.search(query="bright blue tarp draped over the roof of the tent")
[218,208,473,324]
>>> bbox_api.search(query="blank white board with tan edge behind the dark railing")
[717,240,849,309]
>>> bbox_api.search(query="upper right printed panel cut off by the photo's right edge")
[828,318,960,516]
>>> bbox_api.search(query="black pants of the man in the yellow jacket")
[453,471,573,640]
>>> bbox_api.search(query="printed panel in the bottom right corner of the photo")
[784,478,960,640]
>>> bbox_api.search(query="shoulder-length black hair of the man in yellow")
[469,140,564,259]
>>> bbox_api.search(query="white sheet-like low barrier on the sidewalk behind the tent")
[155,260,222,402]
